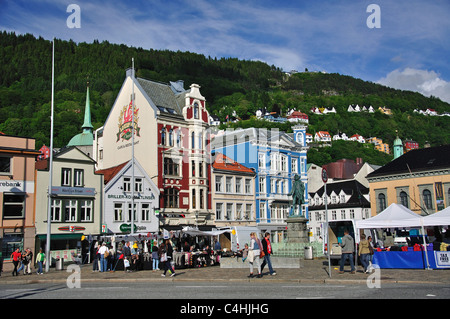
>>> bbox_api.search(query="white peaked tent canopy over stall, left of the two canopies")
[356,203,421,228]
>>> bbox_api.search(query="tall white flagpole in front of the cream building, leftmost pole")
[45,38,55,272]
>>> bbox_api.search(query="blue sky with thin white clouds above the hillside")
[0,0,450,102]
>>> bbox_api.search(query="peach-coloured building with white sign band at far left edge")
[0,135,40,260]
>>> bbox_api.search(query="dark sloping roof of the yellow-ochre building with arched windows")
[367,144,450,178]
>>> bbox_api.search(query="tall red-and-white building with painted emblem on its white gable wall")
[94,69,213,228]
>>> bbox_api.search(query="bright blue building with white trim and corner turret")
[211,125,309,242]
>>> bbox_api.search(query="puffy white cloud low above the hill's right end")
[378,68,450,103]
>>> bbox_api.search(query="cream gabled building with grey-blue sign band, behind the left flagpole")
[35,147,103,259]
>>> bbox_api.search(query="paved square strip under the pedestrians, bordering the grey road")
[0,258,450,286]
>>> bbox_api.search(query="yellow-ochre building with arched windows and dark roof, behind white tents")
[367,145,450,216]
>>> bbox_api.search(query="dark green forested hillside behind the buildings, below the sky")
[0,32,450,166]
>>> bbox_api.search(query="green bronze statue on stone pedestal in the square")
[286,175,309,243]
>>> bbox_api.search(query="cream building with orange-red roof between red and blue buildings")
[212,153,256,227]
